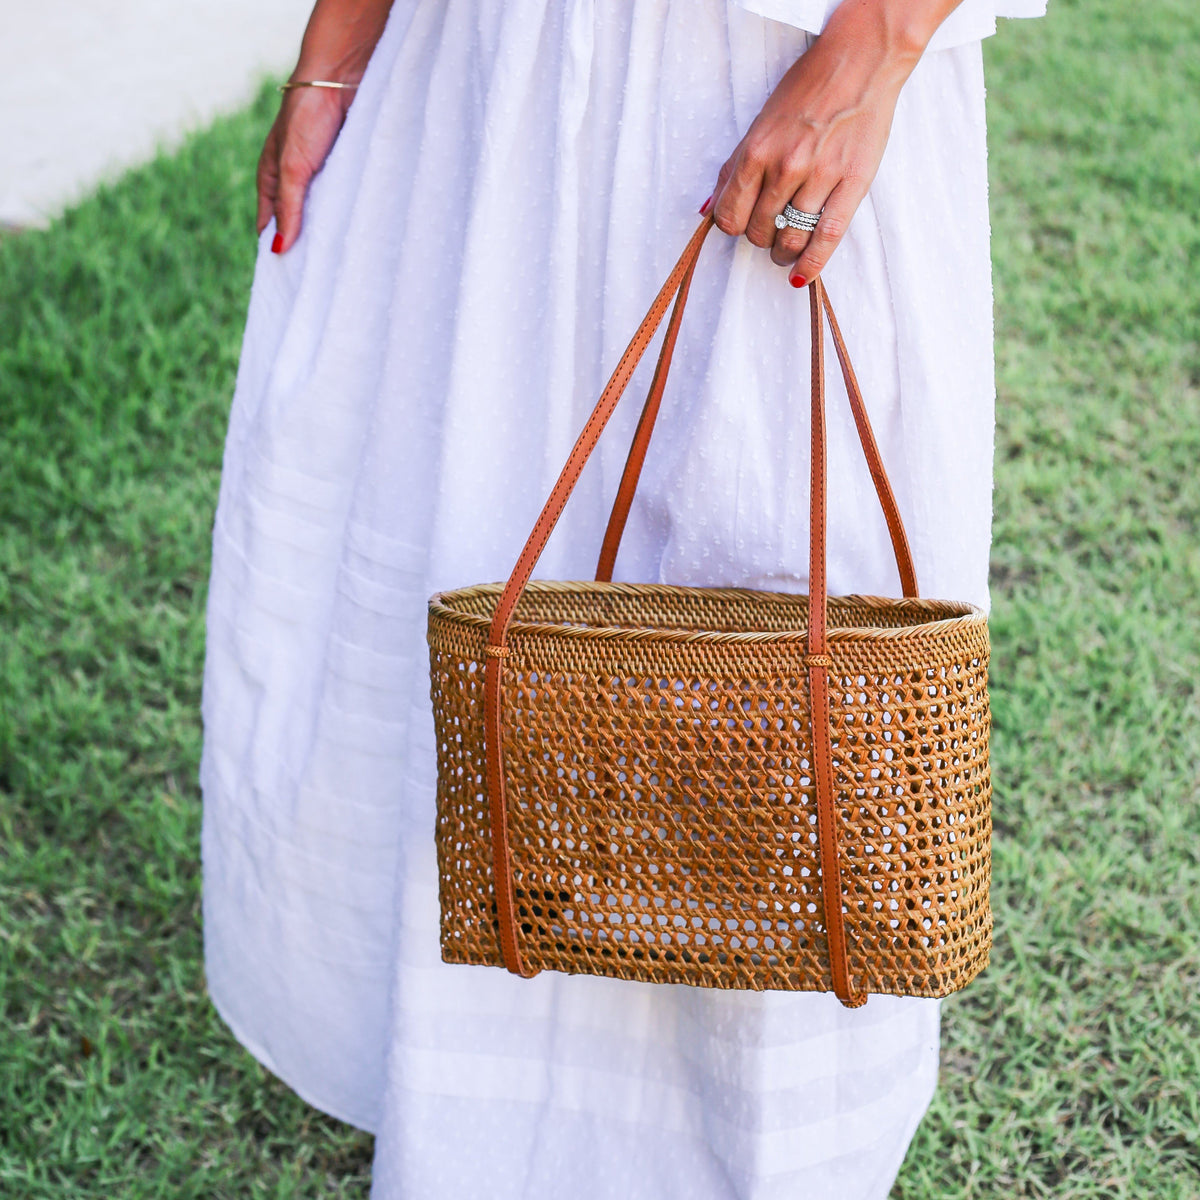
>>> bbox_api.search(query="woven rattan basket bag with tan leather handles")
[428,215,991,1006]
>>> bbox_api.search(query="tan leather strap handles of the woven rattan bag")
[484,214,917,1007]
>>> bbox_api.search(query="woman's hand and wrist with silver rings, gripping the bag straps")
[701,0,959,287]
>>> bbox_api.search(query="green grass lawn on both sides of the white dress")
[0,0,1200,1200]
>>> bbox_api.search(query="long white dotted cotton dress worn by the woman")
[200,0,1038,1200]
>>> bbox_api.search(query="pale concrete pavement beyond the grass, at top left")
[0,0,312,227]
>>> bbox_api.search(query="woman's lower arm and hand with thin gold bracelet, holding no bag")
[257,0,392,254]
